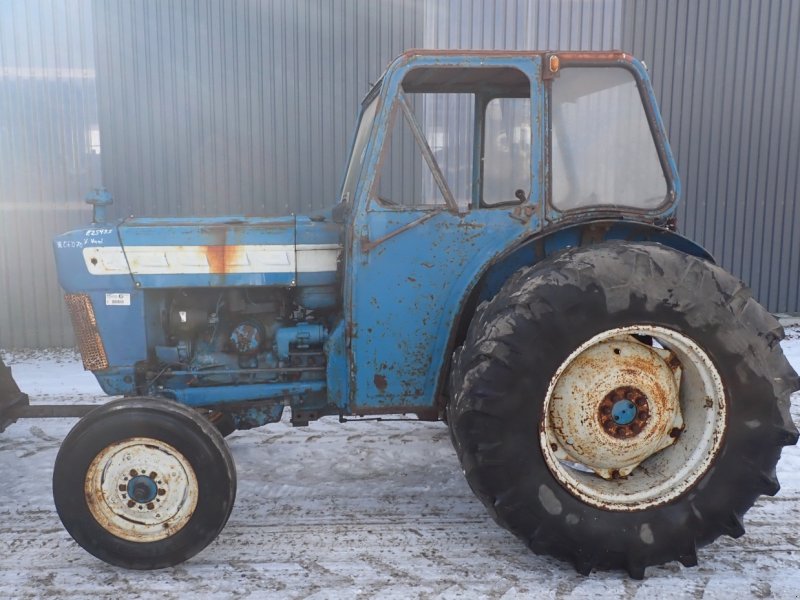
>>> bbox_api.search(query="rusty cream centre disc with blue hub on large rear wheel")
[549,335,683,479]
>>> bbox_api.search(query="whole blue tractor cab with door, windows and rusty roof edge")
[337,50,684,418]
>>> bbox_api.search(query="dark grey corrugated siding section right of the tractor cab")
[623,0,800,312]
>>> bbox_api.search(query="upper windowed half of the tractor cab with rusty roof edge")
[340,50,679,230]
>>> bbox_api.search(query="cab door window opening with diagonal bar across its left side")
[372,67,531,212]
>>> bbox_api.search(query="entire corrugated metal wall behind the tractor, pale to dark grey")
[0,0,800,348]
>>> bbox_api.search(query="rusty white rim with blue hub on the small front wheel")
[84,437,198,542]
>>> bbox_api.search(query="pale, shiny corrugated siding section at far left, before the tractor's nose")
[0,0,100,348]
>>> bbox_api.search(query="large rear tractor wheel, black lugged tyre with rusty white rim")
[448,242,798,578]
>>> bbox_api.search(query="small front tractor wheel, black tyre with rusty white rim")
[53,398,236,569]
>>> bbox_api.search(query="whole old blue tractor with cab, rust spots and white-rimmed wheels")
[0,50,798,577]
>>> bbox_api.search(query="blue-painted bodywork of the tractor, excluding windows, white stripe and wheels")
[54,51,710,427]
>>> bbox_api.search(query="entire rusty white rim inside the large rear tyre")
[539,325,727,511]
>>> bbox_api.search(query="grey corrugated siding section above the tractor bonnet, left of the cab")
[94,0,422,216]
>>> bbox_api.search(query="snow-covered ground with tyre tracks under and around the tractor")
[0,329,800,599]
